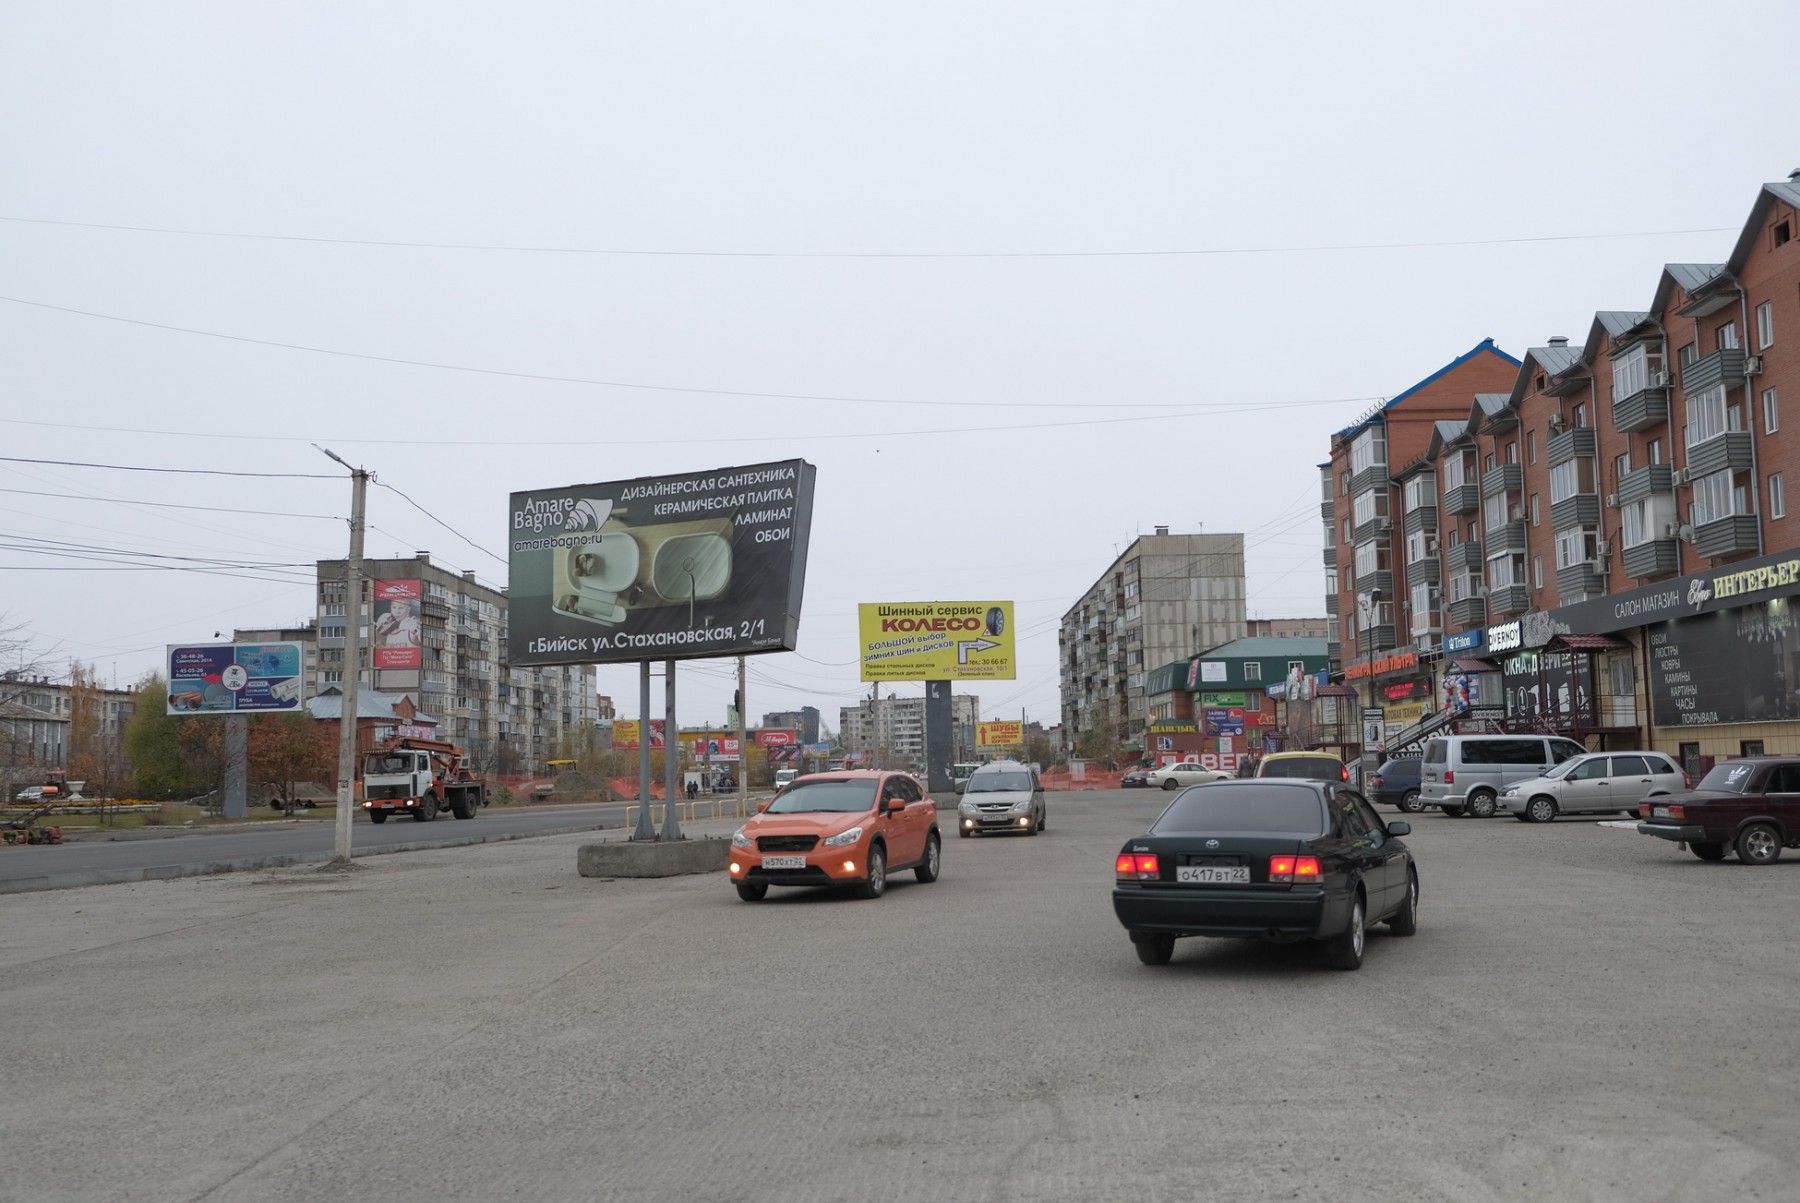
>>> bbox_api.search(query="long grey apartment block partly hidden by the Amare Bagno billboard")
[317,551,599,773]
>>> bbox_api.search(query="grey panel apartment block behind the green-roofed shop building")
[1057,526,1246,747]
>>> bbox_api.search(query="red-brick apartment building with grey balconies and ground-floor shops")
[1323,173,1800,769]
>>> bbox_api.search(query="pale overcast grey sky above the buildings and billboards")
[0,0,1800,728]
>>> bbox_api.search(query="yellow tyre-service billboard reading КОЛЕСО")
[857,602,1019,681]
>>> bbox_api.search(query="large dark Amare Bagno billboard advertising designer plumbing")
[508,459,815,665]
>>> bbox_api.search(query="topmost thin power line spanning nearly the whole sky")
[0,216,1733,259]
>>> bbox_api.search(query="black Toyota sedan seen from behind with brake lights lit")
[1112,778,1418,969]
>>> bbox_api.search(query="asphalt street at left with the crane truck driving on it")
[0,805,625,893]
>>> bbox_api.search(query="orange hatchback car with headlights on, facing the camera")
[731,773,943,902]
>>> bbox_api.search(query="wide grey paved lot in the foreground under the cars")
[0,792,1800,1203]
